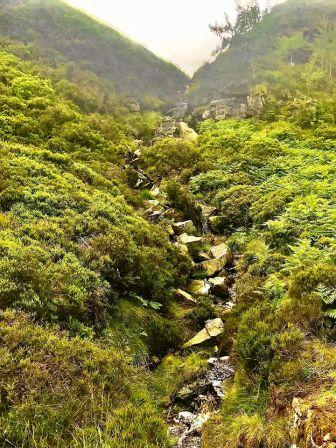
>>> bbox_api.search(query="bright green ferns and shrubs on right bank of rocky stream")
[190,120,336,448]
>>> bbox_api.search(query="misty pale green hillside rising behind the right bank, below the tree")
[190,0,335,105]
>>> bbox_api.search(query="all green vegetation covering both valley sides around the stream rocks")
[0,0,336,448]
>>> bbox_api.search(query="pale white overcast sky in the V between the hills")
[67,0,284,74]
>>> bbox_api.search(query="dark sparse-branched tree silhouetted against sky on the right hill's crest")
[209,0,270,55]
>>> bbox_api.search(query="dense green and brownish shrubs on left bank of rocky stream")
[0,47,191,448]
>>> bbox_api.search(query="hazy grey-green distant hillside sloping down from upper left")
[0,0,188,104]
